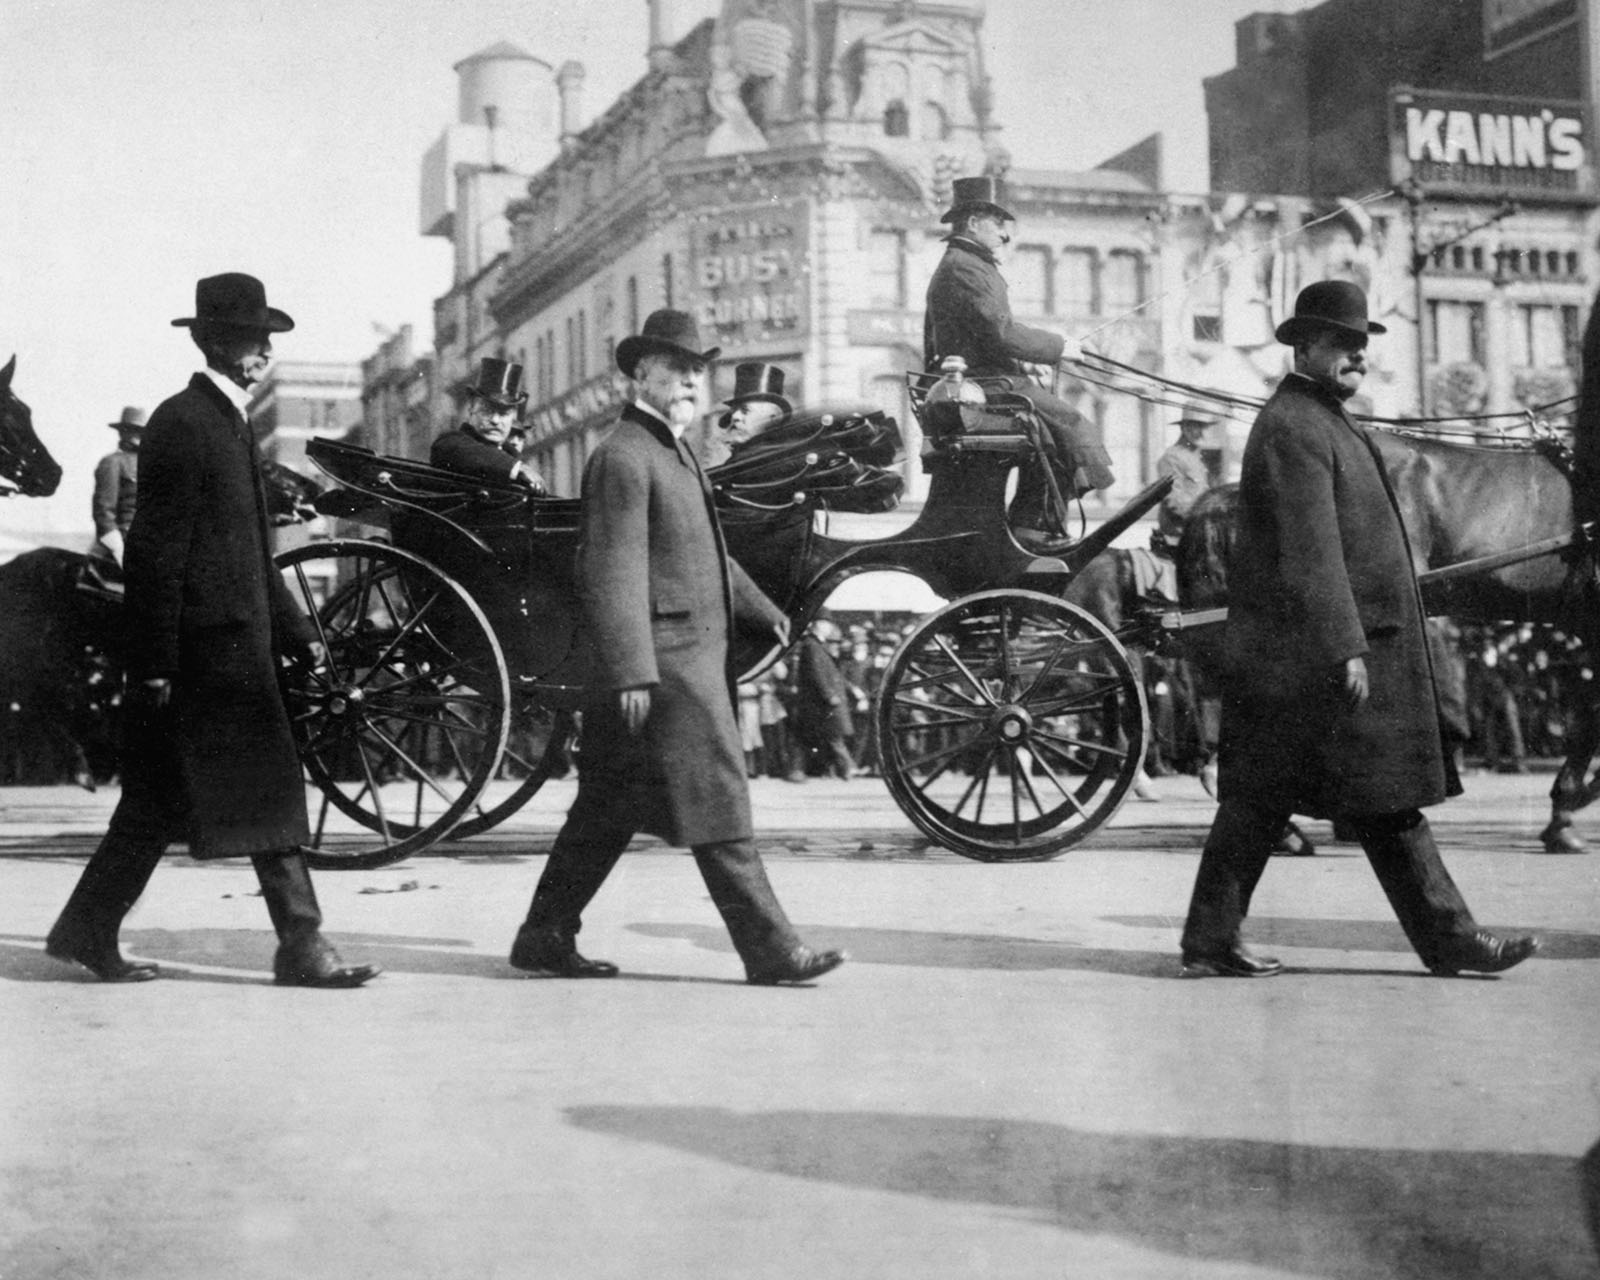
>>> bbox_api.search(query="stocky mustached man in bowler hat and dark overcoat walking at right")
[1182,280,1538,978]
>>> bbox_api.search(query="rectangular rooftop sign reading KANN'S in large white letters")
[1389,90,1595,200]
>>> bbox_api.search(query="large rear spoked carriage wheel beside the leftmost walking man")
[277,539,510,869]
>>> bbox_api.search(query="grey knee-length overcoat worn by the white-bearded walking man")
[576,405,782,845]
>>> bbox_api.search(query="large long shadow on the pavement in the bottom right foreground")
[566,1106,1595,1280]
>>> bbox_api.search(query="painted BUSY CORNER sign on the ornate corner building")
[691,202,810,352]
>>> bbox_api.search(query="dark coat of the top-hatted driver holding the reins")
[922,237,1112,489]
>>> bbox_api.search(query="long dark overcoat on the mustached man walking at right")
[1219,374,1459,818]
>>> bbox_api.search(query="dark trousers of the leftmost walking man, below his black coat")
[53,805,322,942]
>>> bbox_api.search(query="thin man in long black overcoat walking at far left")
[45,274,378,987]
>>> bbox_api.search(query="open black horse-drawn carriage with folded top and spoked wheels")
[278,378,1165,867]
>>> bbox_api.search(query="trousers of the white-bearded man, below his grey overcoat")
[522,786,800,970]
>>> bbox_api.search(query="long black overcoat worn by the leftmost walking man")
[120,374,312,858]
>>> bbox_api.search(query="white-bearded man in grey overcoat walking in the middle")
[510,310,845,986]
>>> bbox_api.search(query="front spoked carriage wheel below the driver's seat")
[877,590,1149,862]
